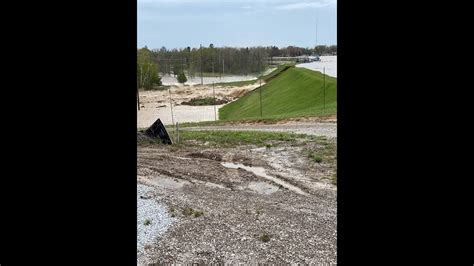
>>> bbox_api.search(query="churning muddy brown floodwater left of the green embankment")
[137,84,258,128]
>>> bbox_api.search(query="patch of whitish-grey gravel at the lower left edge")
[137,184,175,264]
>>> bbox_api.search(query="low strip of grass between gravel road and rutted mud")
[180,130,308,147]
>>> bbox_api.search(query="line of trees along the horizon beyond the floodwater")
[137,44,337,80]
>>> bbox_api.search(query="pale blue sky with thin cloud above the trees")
[137,0,337,49]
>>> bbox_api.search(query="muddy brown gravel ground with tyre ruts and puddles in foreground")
[137,134,337,264]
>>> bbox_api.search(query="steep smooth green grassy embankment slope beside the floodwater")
[219,67,337,120]
